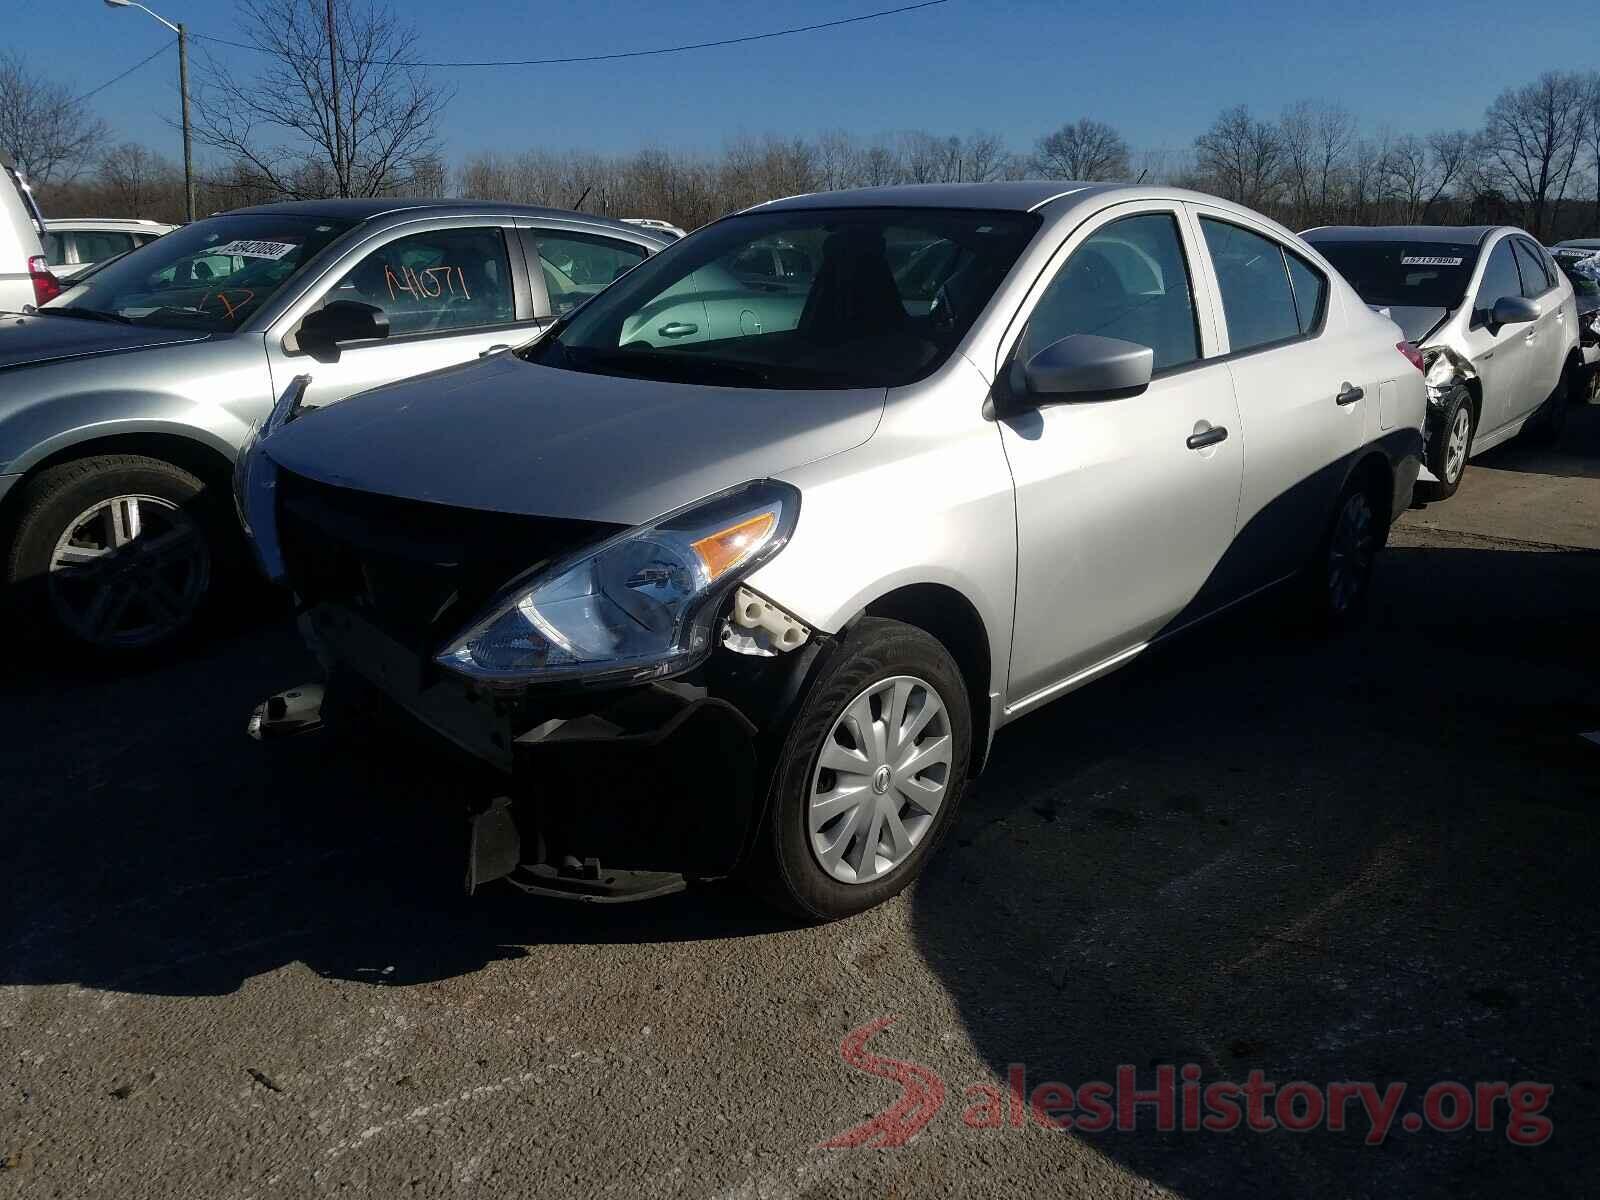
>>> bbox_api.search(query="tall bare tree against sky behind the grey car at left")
[195,0,454,197]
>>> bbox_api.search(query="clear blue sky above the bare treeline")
[18,0,1600,162]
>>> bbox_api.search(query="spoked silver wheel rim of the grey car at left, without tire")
[50,496,211,648]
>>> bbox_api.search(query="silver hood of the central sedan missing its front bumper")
[262,354,886,525]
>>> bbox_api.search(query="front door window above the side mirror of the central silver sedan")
[1019,213,1200,371]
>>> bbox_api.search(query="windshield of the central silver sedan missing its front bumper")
[523,208,1038,389]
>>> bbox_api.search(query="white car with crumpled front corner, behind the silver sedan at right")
[1304,226,1582,499]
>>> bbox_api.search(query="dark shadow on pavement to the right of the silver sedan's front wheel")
[914,547,1600,1195]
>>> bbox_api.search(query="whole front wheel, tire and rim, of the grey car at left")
[8,454,216,659]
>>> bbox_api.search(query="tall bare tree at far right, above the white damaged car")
[1483,70,1592,237]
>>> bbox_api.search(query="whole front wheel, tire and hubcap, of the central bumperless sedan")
[750,618,973,920]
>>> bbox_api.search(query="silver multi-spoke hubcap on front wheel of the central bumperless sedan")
[806,675,954,883]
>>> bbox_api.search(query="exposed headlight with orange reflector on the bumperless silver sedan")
[437,480,800,685]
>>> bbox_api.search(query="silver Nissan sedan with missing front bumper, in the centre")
[240,182,1426,918]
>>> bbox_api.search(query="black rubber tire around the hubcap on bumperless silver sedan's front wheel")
[746,618,973,922]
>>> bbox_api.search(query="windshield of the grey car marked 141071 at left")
[43,213,352,333]
